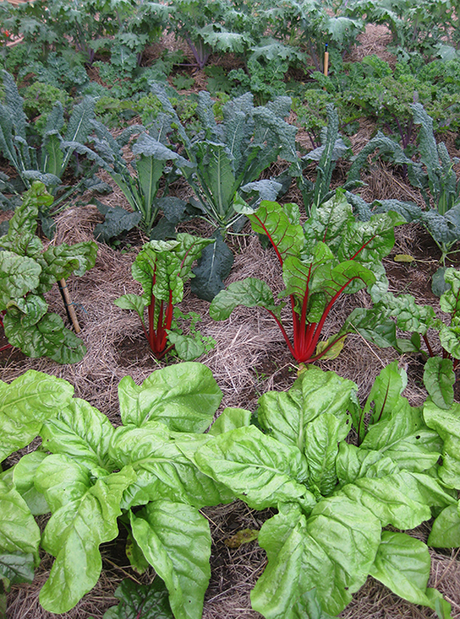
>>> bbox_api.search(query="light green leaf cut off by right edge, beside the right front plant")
[423,400,460,488]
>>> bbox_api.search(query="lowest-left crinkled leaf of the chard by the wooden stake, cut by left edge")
[0,251,41,311]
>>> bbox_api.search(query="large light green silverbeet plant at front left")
[0,363,235,619]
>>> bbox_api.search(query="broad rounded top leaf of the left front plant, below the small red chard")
[118,362,222,433]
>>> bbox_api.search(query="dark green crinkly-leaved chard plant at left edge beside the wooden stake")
[0,181,97,363]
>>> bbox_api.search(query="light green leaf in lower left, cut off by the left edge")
[0,480,40,565]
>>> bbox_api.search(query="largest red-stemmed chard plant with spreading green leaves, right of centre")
[209,191,401,363]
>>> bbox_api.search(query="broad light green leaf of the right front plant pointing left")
[195,426,316,509]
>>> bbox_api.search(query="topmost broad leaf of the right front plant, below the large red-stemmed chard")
[258,366,356,451]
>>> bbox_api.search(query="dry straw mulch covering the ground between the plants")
[0,21,460,619]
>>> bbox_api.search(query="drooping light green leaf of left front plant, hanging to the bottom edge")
[130,500,211,619]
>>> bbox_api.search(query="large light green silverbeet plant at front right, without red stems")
[194,362,460,619]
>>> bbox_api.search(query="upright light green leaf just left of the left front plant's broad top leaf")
[40,398,116,472]
